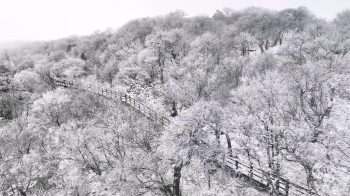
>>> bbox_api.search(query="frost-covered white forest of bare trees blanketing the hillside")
[0,7,350,196]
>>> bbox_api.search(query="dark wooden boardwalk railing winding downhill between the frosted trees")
[54,78,317,196]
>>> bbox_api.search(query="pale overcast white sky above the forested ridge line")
[0,0,350,42]
